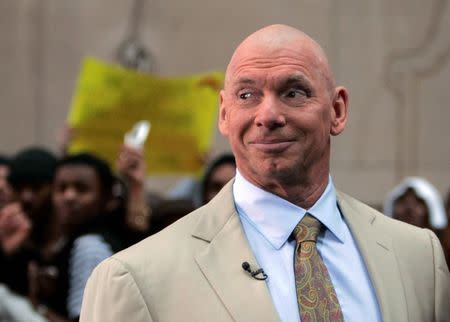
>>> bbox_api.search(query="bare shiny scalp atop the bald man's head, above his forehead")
[225,24,334,92]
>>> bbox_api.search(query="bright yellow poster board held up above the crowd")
[68,58,224,174]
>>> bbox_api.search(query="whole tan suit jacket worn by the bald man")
[81,183,450,322]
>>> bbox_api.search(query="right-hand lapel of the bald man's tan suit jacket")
[338,193,407,322]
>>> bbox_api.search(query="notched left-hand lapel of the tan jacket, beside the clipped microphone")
[193,183,279,322]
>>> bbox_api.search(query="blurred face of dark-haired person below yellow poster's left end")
[52,164,105,231]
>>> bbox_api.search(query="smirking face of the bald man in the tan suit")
[219,41,338,186]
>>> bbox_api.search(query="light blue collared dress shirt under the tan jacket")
[233,171,382,322]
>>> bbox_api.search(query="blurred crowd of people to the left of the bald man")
[0,145,235,321]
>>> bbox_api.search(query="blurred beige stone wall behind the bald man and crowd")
[0,0,450,205]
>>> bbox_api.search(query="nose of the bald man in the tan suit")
[255,96,286,129]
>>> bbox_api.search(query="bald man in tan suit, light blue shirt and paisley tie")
[81,25,450,322]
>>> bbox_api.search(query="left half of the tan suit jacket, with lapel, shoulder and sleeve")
[81,184,279,322]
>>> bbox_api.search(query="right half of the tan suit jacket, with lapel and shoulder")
[338,192,450,321]
